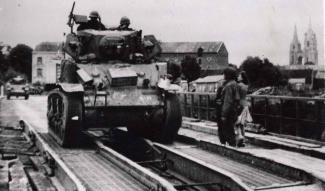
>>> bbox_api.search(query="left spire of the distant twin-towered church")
[289,25,303,65]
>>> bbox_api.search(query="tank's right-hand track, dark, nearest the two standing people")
[153,94,182,143]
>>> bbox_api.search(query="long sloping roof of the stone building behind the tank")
[161,41,223,53]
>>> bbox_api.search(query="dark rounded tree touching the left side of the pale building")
[9,44,33,81]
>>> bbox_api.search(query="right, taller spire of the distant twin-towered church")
[304,21,318,65]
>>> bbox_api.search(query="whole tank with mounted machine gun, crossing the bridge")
[47,2,181,147]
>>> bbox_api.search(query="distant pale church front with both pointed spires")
[289,23,318,65]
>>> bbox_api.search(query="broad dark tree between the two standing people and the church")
[240,57,286,88]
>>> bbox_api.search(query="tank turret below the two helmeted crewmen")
[64,29,161,63]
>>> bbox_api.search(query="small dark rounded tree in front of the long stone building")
[181,55,201,84]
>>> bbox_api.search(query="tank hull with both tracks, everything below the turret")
[48,57,182,147]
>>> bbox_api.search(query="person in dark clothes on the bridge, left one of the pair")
[218,67,240,146]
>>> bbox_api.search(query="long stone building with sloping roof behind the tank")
[161,41,228,74]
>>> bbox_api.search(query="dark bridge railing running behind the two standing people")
[179,92,325,141]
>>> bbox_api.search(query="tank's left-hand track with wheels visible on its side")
[47,89,83,147]
